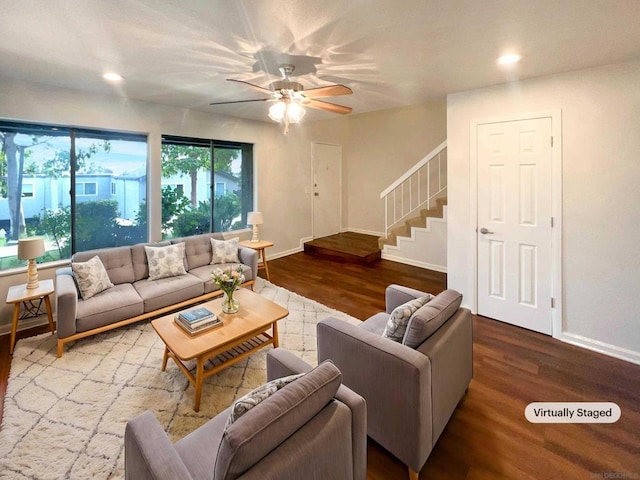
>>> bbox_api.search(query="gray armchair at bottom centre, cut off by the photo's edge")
[125,349,367,480]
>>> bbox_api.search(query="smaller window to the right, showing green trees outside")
[162,136,253,238]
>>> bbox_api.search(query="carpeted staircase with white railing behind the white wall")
[378,141,447,272]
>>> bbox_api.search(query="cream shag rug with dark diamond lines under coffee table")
[0,279,359,480]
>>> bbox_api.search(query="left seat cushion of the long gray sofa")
[76,283,144,332]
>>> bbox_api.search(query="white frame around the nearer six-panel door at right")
[469,109,564,338]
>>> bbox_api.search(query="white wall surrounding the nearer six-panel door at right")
[447,61,640,363]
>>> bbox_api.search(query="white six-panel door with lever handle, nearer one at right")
[477,117,553,334]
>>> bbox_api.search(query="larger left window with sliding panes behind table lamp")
[0,121,147,269]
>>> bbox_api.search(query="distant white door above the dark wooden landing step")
[311,143,342,238]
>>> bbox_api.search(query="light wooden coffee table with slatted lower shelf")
[151,288,289,412]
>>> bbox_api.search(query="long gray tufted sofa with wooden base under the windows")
[56,233,258,357]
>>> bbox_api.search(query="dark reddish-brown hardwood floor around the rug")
[0,253,640,480]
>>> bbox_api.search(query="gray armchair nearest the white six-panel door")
[318,285,473,480]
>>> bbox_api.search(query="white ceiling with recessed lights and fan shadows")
[0,0,640,120]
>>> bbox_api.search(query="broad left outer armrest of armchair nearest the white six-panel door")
[318,318,432,471]
